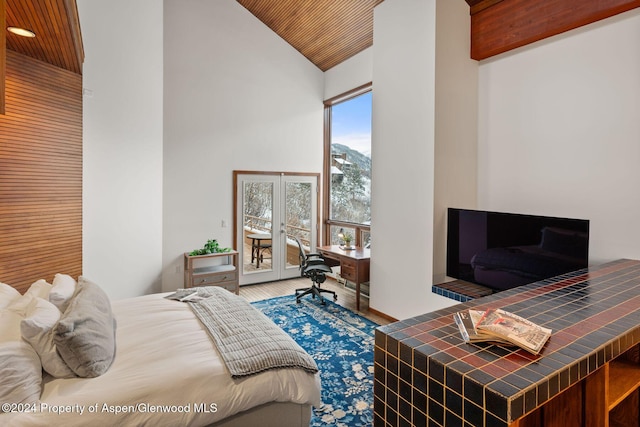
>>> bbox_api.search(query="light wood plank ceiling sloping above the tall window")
[237,0,383,71]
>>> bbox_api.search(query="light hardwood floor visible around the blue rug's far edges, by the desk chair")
[240,278,391,325]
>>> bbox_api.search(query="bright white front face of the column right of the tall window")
[370,0,451,319]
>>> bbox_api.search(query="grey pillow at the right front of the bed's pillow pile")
[53,276,116,378]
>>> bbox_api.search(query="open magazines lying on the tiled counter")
[453,308,551,354]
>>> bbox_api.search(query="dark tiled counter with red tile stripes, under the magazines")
[374,260,640,426]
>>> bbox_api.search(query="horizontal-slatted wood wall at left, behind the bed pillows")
[0,50,82,292]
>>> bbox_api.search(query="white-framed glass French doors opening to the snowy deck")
[234,171,319,285]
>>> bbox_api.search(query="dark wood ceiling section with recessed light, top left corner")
[6,0,84,74]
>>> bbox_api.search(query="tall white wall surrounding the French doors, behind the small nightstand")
[163,0,324,290]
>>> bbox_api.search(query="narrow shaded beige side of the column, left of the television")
[433,0,478,283]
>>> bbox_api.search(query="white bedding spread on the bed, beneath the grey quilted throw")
[0,294,320,426]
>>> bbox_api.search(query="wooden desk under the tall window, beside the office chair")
[316,245,371,311]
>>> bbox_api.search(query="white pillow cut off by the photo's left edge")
[0,310,42,403]
